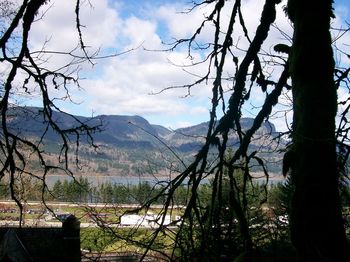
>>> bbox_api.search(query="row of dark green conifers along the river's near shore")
[0,177,306,210]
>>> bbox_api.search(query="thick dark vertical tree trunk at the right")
[288,0,350,261]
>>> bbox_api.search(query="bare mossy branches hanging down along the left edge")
[0,0,103,225]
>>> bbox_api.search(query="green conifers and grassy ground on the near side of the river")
[0,178,350,261]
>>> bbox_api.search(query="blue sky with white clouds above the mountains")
[12,0,350,131]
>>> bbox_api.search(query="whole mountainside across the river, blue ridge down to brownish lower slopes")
[5,107,281,176]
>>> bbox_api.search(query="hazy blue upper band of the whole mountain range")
[6,107,276,152]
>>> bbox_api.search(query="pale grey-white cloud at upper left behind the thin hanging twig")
[30,0,122,69]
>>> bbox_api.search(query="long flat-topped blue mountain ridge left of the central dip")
[9,107,158,148]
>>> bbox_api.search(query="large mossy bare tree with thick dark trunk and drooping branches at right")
[135,0,349,261]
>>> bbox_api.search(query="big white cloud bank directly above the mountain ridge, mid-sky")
[76,3,215,123]
